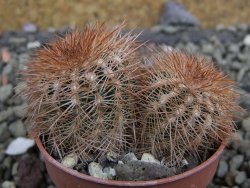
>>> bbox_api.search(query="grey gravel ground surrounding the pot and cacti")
[0,25,250,188]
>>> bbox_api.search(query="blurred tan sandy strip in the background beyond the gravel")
[0,0,250,31]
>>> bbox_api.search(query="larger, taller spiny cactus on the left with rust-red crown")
[22,24,138,162]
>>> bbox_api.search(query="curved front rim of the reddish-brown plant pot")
[35,138,226,187]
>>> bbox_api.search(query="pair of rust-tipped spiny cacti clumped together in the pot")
[23,24,240,165]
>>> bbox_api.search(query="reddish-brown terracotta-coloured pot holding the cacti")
[36,139,225,188]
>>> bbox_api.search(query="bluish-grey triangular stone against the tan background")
[160,0,200,26]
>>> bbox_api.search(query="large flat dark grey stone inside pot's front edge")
[115,160,174,181]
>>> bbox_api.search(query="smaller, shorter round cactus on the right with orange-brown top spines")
[138,50,240,166]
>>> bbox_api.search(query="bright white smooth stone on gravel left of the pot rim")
[5,137,35,155]
